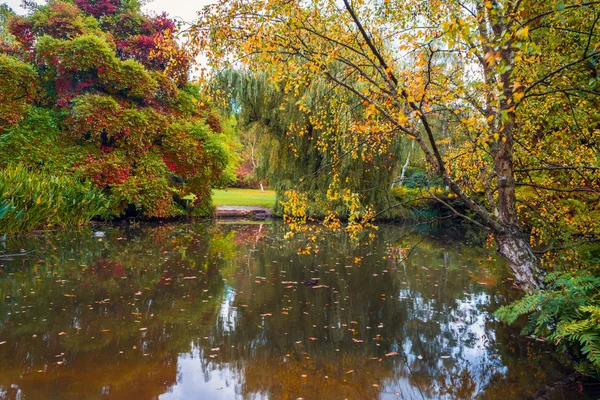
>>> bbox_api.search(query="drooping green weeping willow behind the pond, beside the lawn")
[212,69,420,216]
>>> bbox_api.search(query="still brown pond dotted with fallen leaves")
[0,222,589,400]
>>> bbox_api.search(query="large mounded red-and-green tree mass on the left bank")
[0,0,228,227]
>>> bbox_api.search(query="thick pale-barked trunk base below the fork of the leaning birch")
[496,232,545,292]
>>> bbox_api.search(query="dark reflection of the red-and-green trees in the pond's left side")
[0,225,223,399]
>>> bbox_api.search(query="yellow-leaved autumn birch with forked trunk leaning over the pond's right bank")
[195,0,600,289]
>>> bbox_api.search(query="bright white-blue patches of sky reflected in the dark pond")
[160,285,507,400]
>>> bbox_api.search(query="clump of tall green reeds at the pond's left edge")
[0,165,108,234]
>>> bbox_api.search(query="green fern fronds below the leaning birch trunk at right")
[496,269,600,377]
